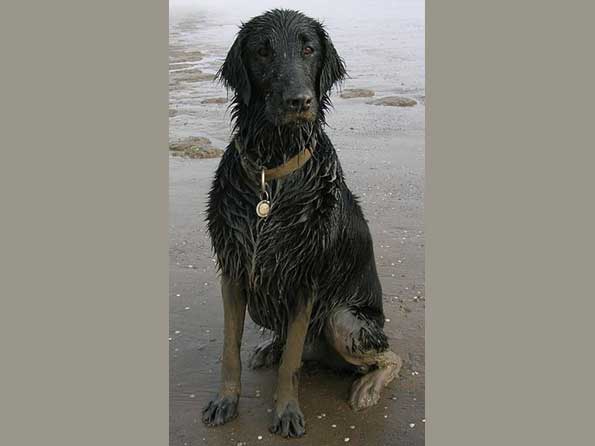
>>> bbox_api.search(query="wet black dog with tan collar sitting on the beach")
[203,10,401,437]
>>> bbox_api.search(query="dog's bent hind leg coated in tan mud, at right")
[325,308,403,410]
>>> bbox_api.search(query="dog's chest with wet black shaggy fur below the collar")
[208,150,341,295]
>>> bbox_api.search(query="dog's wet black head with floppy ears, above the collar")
[218,9,346,126]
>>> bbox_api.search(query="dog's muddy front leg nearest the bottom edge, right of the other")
[271,299,312,437]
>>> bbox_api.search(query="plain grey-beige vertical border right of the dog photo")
[426,0,595,446]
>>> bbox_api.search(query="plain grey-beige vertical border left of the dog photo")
[0,0,168,446]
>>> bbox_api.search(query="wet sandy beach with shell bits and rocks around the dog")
[169,0,425,446]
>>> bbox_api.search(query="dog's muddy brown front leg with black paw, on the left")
[202,276,246,426]
